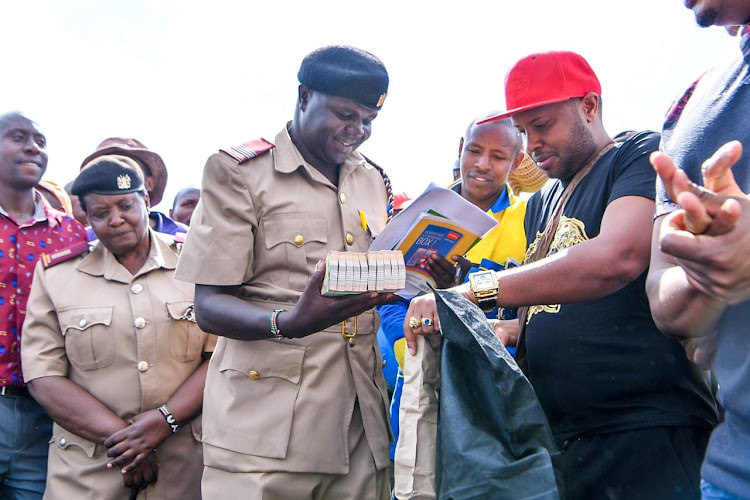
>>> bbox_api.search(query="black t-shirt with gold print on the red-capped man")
[525,132,717,440]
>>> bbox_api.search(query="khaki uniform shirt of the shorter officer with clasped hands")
[22,230,216,499]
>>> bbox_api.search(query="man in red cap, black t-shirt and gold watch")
[405,52,717,498]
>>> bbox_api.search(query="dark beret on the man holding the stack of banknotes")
[297,45,388,109]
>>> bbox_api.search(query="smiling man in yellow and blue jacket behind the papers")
[378,114,526,458]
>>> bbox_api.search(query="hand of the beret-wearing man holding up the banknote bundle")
[278,261,398,337]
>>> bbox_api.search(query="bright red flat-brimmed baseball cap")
[477,52,602,125]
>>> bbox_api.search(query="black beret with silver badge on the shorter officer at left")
[70,155,145,196]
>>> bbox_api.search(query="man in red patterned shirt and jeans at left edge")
[0,112,87,499]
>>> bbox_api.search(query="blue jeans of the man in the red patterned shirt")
[0,396,52,500]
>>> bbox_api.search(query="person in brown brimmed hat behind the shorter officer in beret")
[81,137,187,235]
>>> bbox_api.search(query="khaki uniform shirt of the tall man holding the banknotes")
[176,124,390,474]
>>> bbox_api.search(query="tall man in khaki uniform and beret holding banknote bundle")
[176,46,390,500]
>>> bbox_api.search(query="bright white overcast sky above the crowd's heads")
[0,0,735,211]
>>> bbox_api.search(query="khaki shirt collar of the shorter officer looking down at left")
[76,228,177,283]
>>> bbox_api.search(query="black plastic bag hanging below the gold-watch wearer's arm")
[435,290,562,500]
